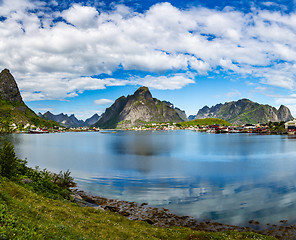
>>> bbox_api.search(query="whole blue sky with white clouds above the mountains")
[0,0,296,119]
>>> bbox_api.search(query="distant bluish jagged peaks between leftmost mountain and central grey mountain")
[38,111,100,128]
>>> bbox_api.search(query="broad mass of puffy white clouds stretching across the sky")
[0,0,296,101]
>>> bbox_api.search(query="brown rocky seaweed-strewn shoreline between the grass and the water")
[72,189,296,240]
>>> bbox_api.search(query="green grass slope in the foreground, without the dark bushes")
[0,179,274,239]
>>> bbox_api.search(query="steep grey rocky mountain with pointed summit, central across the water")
[95,87,182,128]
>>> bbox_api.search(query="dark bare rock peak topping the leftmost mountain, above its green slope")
[0,69,23,102]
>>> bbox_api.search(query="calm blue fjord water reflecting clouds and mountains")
[2,131,296,224]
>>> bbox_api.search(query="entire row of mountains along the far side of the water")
[0,69,293,128]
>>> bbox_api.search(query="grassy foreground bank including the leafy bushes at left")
[0,144,274,240]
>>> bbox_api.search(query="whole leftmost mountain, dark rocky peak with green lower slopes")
[0,69,58,127]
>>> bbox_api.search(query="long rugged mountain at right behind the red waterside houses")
[195,99,293,124]
